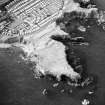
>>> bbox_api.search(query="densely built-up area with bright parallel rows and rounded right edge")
[6,0,63,35]
